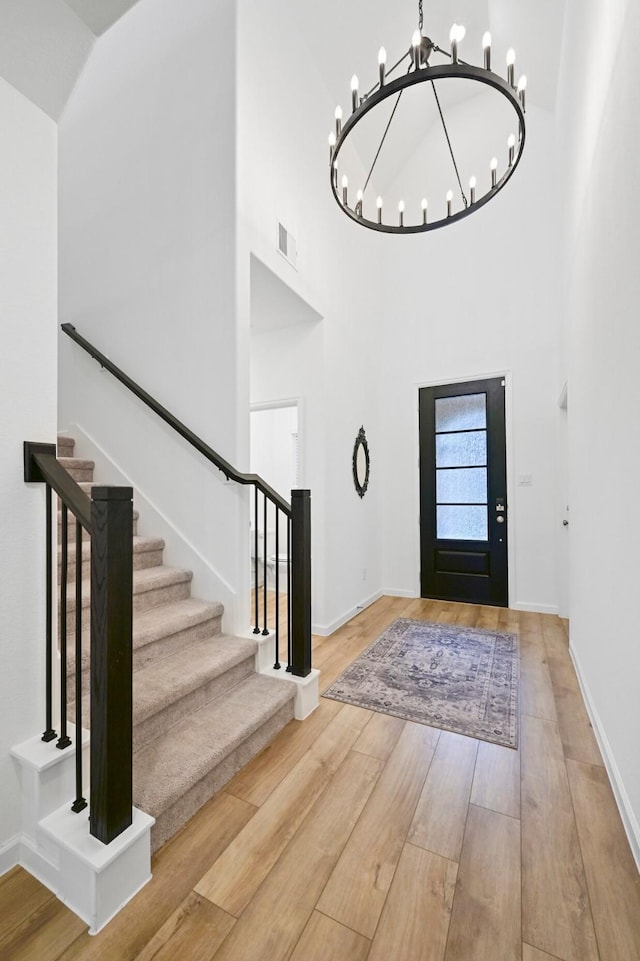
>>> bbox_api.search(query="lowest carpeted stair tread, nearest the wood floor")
[133,674,295,818]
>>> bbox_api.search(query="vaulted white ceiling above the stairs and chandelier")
[0,0,565,119]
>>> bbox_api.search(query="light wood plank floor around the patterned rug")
[0,598,640,961]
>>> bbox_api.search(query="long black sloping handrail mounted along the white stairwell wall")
[62,324,291,517]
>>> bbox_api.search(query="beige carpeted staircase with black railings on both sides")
[58,437,295,851]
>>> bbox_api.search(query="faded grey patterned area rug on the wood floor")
[324,618,518,748]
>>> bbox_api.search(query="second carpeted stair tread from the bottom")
[133,634,258,725]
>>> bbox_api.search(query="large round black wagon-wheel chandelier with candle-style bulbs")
[329,0,527,234]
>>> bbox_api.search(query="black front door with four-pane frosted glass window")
[420,377,509,607]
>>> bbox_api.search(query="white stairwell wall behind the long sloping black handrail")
[59,0,242,629]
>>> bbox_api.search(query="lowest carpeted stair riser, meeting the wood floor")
[146,701,293,853]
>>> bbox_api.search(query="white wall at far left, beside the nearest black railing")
[0,80,56,852]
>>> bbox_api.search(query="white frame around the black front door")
[412,369,517,607]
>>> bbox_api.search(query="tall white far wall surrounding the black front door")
[378,106,559,612]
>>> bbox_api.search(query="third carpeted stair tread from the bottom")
[67,597,224,675]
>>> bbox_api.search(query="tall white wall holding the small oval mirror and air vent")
[238,0,383,633]
